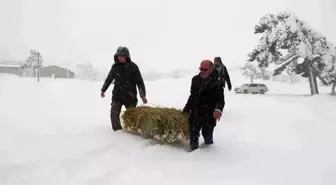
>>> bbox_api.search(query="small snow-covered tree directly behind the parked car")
[242,62,269,83]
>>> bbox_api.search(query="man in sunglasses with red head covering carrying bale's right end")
[183,60,225,150]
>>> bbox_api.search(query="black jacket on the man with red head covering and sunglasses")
[183,70,225,119]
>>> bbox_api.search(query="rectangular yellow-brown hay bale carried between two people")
[122,106,189,143]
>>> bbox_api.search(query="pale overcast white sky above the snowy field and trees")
[0,0,336,71]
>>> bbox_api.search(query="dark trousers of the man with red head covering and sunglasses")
[189,117,216,150]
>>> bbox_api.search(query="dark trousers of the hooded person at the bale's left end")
[110,101,137,131]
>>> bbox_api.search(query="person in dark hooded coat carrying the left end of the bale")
[101,47,147,131]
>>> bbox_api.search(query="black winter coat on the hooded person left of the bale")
[101,56,146,104]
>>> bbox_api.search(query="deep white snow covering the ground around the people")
[0,75,336,185]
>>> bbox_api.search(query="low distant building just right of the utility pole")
[40,65,75,78]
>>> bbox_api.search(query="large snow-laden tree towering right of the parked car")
[249,12,330,94]
